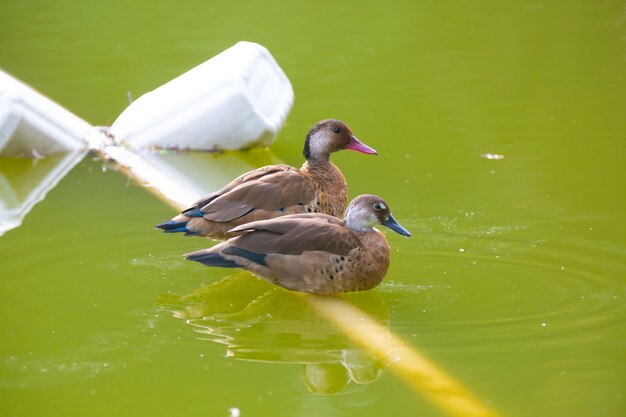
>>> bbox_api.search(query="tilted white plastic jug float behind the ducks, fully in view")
[111,42,294,150]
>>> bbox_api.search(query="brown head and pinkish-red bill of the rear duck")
[303,119,377,160]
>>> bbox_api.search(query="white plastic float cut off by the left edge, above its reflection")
[0,70,94,157]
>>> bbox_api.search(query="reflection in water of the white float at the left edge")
[0,151,85,236]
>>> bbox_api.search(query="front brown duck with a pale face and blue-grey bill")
[185,194,411,294]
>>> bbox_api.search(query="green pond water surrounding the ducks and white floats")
[0,0,626,417]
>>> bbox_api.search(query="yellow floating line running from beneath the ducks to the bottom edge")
[302,294,497,417]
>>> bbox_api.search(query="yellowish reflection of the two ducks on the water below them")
[156,273,389,395]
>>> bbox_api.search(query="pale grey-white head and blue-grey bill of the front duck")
[344,194,411,237]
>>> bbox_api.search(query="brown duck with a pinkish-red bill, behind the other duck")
[155,119,377,240]
